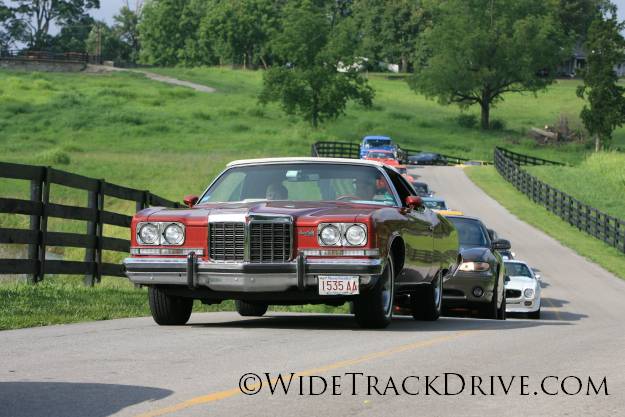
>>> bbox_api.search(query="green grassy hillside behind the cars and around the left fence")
[0,68,625,328]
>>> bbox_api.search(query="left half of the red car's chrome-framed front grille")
[208,222,245,262]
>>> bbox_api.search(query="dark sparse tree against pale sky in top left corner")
[10,0,100,49]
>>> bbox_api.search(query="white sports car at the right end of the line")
[505,260,540,319]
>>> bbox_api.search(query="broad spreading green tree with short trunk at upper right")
[409,0,572,129]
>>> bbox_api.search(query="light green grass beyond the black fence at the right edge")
[527,152,625,220]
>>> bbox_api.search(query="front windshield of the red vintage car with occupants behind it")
[200,163,400,206]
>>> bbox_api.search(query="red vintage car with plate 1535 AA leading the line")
[124,158,458,328]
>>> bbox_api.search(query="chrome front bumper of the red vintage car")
[123,255,385,292]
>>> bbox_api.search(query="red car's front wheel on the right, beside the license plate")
[354,257,395,329]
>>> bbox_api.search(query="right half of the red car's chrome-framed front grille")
[250,222,292,263]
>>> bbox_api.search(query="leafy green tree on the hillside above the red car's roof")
[260,0,373,127]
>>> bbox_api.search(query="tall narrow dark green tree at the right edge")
[577,5,625,151]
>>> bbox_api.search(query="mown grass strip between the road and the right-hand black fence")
[466,167,625,279]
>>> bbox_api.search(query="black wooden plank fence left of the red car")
[0,162,181,285]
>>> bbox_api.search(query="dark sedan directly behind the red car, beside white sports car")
[443,216,510,320]
